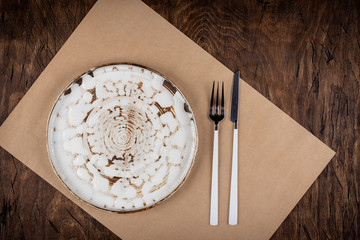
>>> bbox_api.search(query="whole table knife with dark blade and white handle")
[229,71,240,225]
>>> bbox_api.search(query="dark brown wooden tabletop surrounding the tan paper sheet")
[0,0,360,239]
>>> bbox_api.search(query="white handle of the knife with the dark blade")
[229,127,238,225]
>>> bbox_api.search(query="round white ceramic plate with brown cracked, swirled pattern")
[47,64,198,212]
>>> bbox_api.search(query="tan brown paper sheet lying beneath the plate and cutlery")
[0,0,334,239]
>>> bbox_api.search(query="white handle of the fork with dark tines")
[210,126,219,226]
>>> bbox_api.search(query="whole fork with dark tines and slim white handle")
[209,81,225,226]
